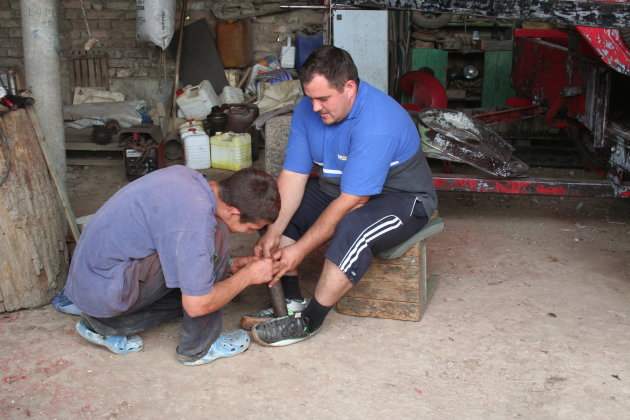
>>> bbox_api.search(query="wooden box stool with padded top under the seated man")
[337,216,444,321]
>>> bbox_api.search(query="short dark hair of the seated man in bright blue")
[300,45,359,92]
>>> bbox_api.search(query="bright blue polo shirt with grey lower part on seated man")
[283,80,437,215]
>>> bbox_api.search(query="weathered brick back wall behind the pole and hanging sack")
[0,0,322,105]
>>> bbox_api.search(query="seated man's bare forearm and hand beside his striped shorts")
[269,192,370,286]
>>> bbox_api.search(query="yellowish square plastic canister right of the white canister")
[210,132,252,171]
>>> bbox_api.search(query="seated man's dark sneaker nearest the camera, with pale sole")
[252,314,319,347]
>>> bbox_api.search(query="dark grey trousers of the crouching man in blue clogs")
[81,220,230,361]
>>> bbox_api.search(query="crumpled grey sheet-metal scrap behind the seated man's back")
[410,108,529,178]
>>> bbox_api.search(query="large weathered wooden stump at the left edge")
[0,109,68,312]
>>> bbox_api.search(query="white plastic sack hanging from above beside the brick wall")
[136,0,176,50]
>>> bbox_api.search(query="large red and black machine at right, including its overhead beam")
[336,0,630,197]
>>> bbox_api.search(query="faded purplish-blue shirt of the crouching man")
[65,165,222,318]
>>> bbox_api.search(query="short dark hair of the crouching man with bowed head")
[218,168,280,223]
